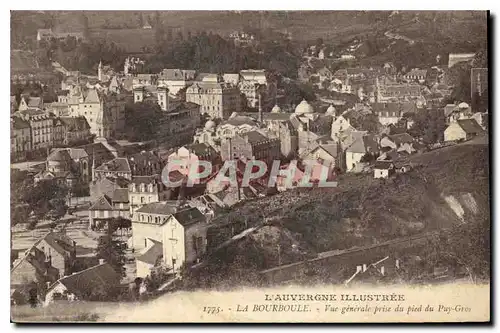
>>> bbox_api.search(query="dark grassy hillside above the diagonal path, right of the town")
[210,140,488,252]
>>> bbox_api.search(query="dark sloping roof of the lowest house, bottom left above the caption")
[49,263,120,296]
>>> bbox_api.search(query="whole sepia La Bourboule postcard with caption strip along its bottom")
[10,10,491,323]
